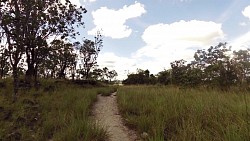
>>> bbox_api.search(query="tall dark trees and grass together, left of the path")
[0,0,117,141]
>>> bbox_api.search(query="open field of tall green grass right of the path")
[118,86,250,141]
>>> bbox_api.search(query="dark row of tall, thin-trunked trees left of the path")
[0,0,117,98]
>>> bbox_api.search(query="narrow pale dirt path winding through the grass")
[93,93,137,141]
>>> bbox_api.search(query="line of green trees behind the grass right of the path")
[123,43,250,90]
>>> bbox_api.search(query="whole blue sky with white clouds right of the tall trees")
[71,0,250,79]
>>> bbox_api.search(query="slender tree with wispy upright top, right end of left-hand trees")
[75,32,103,79]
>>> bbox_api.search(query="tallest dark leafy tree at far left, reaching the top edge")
[0,0,87,95]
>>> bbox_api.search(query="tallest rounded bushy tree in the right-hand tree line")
[193,43,238,90]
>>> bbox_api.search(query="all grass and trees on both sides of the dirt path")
[0,0,250,141]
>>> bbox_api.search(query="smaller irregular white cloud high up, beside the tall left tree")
[88,2,146,39]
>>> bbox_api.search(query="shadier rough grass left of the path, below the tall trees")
[0,81,114,141]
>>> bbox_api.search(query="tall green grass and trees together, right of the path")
[118,43,250,141]
